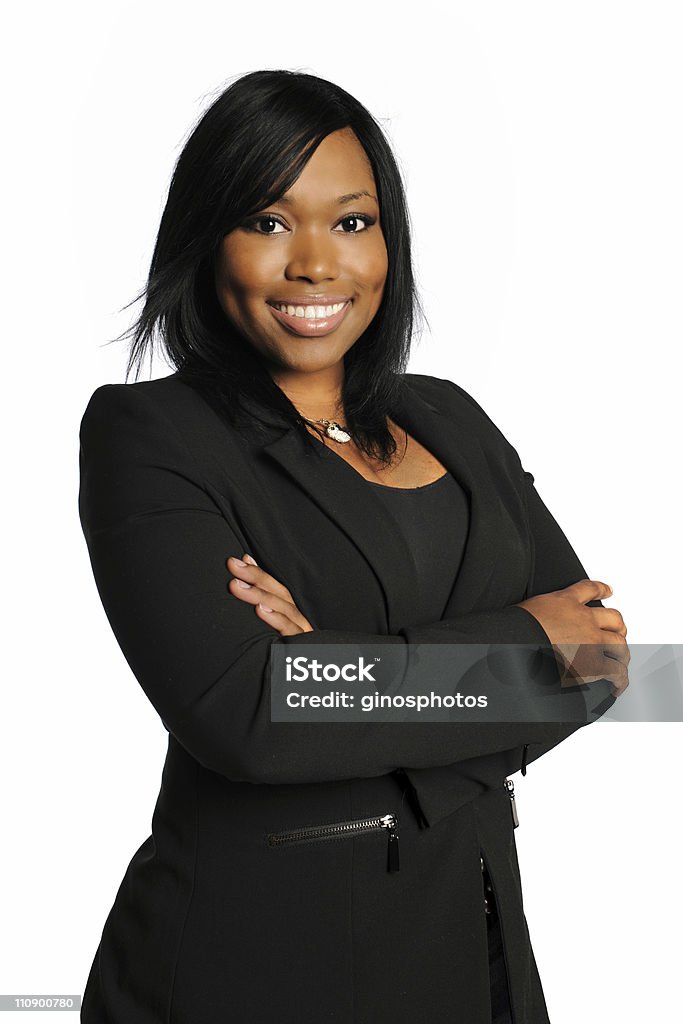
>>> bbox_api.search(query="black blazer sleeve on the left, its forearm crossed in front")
[79,384,610,783]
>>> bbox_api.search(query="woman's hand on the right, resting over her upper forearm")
[519,580,631,696]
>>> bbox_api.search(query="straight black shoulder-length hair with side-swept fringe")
[113,71,424,463]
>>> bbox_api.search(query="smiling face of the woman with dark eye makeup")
[215,129,388,376]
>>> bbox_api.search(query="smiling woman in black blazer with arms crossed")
[79,71,628,1024]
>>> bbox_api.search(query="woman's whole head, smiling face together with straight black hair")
[112,71,422,475]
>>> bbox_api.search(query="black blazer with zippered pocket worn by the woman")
[79,374,609,1024]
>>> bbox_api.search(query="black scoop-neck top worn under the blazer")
[367,472,469,626]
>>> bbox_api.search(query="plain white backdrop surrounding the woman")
[0,0,683,1024]
